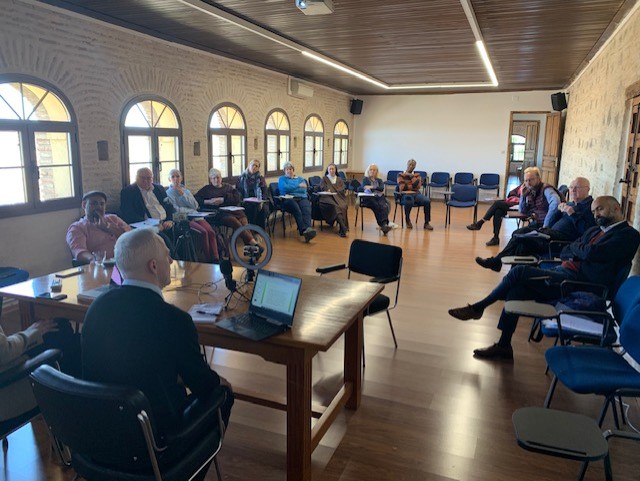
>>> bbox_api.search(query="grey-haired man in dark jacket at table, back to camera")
[82,229,233,480]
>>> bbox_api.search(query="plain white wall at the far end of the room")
[353,91,553,192]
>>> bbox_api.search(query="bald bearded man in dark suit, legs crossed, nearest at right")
[449,196,640,359]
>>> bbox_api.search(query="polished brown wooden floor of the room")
[0,197,640,481]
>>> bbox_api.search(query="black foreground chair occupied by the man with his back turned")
[31,366,226,481]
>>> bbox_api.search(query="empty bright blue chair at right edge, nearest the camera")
[544,305,640,428]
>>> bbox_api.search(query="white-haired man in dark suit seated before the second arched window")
[120,167,174,231]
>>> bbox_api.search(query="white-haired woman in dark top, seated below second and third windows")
[194,169,264,252]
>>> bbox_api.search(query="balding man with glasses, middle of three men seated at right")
[476,177,596,272]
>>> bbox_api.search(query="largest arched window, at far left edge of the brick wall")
[0,76,82,217]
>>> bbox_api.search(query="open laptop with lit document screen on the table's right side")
[216,270,302,341]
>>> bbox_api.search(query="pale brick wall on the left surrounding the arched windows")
[0,0,353,275]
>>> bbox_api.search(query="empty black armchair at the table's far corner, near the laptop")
[316,239,402,366]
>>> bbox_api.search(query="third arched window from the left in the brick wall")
[209,104,247,180]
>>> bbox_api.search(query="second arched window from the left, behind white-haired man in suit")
[122,98,184,185]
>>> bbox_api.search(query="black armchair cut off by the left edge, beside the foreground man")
[0,349,62,451]
